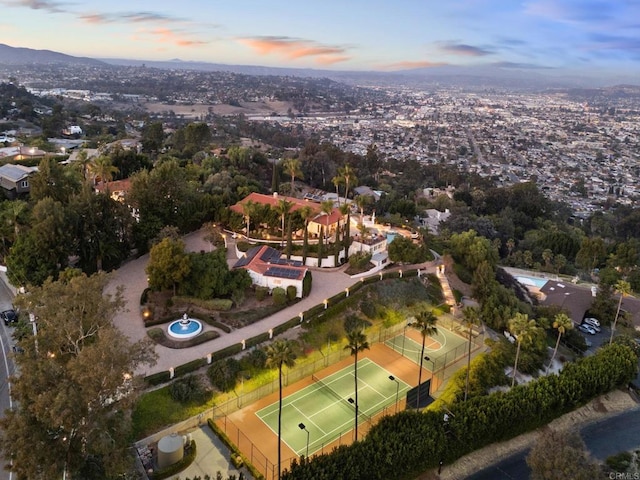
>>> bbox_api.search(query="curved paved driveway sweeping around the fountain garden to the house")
[107,230,436,376]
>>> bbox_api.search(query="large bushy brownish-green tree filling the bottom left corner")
[1,274,155,480]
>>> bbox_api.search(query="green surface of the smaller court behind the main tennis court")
[384,327,468,372]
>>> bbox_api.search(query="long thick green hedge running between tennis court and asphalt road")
[282,344,638,480]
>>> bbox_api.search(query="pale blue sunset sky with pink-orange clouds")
[0,0,640,78]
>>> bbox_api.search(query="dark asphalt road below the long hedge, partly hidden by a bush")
[467,409,640,480]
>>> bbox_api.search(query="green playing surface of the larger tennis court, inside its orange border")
[256,358,410,455]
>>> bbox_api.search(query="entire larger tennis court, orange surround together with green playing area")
[216,342,444,480]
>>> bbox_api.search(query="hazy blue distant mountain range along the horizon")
[0,44,640,90]
